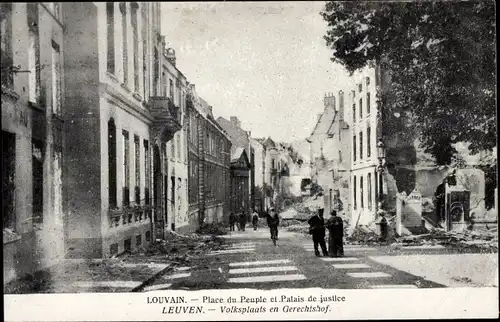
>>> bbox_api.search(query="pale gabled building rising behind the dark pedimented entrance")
[217,116,255,213]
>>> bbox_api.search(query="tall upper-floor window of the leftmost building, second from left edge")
[28,3,41,103]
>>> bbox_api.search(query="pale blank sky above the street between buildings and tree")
[162,1,347,142]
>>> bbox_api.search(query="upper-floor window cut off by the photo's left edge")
[0,3,14,89]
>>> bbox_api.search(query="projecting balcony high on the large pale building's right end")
[148,96,182,142]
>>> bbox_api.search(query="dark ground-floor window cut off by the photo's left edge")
[2,131,16,230]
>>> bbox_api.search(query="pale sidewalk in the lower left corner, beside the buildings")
[4,259,171,294]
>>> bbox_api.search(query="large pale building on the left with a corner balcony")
[62,2,183,258]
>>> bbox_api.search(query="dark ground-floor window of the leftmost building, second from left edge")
[31,139,45,224]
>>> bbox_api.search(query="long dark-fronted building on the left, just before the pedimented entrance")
[183,84,231,231]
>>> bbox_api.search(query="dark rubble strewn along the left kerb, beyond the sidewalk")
[127,231,225,266]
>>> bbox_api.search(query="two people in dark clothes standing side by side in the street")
[308,209,344,257]
